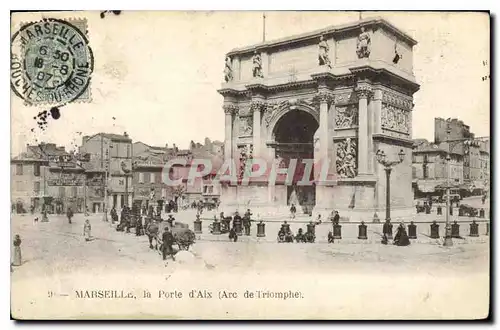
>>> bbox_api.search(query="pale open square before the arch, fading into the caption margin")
[12,211,489,318]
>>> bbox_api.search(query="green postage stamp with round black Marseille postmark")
[11,19,94,105]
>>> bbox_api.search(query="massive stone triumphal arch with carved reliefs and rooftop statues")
[219,18,419,221]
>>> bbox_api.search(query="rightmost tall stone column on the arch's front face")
[356,85,371,176]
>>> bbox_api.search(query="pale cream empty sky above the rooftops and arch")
[11,11,490,155]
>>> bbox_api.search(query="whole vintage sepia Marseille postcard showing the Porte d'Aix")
[10,11,491,320]
